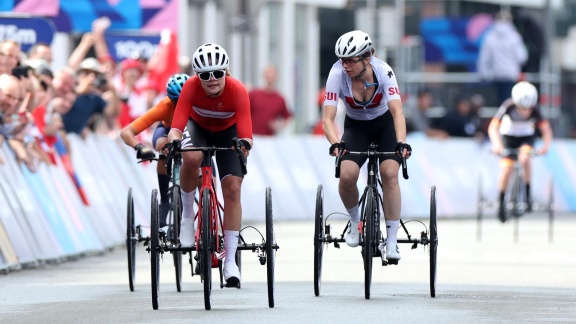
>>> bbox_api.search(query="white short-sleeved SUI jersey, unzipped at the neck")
[324,56,401,120]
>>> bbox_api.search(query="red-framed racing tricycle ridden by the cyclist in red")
[156,138,279,310]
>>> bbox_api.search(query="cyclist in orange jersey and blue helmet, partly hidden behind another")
[120,74,189,227]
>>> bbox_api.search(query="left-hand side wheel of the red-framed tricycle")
[150,189,160,310]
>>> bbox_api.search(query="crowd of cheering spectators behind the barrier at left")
[0,17,191,172]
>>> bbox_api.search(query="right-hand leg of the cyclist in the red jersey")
[212,126,244,284]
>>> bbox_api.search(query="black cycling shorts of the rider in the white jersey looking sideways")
[342,111,401,167]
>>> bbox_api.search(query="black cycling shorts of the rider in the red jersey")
[182,119,244,181]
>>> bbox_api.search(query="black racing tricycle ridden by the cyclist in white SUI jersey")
[314,143,438,299]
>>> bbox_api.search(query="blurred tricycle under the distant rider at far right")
[477,149,554,240]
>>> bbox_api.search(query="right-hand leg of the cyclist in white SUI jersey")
[378,112,401,260]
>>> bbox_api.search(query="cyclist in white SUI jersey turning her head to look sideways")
[323,30,412,261]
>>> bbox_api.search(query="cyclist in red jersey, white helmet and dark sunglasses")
[168,43,252,284]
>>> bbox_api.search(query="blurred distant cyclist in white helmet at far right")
[488,81,552,222]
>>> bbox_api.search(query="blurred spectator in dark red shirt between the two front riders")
[249,65,292,135]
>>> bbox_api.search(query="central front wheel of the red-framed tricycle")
[200,188,212,310]
